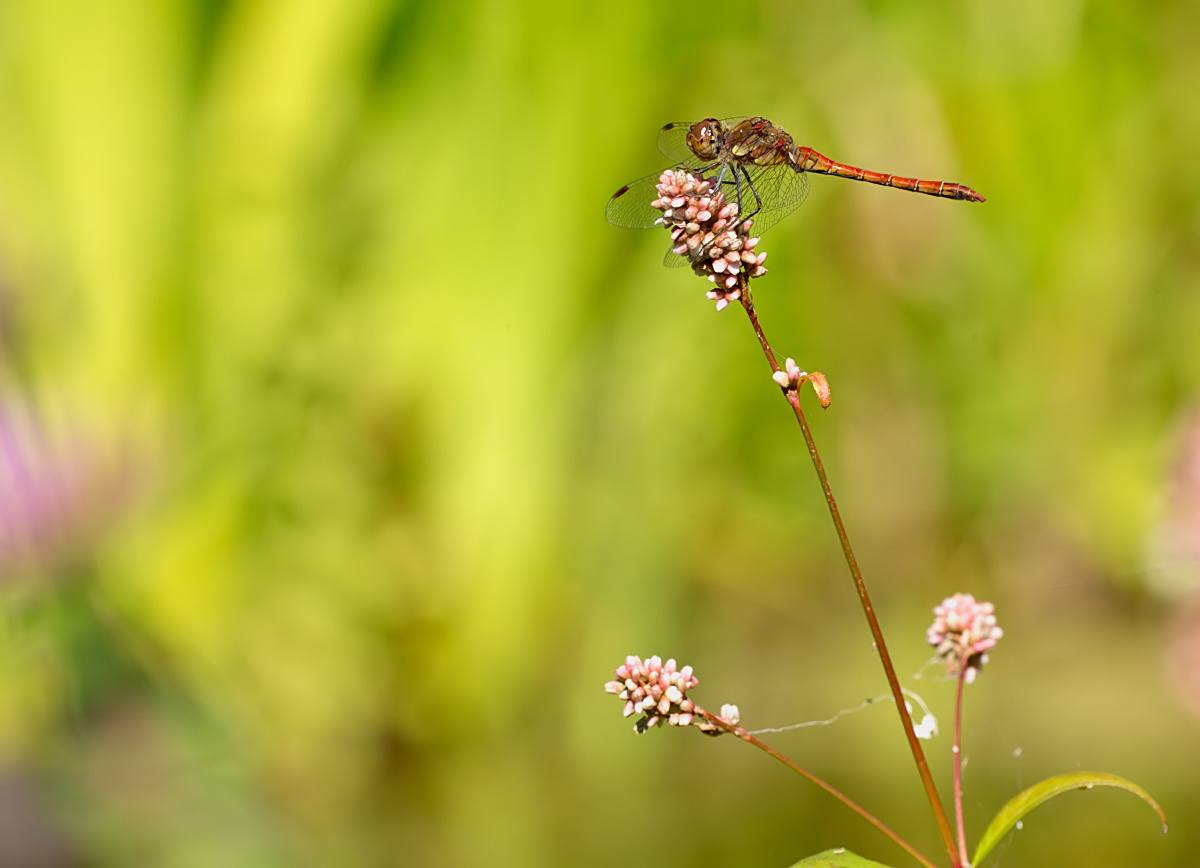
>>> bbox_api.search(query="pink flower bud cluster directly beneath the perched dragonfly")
[650,169,767,310]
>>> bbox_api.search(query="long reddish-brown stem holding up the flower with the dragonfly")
[742,288,964,868]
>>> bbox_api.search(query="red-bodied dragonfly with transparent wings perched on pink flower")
[605,118,986,265]
